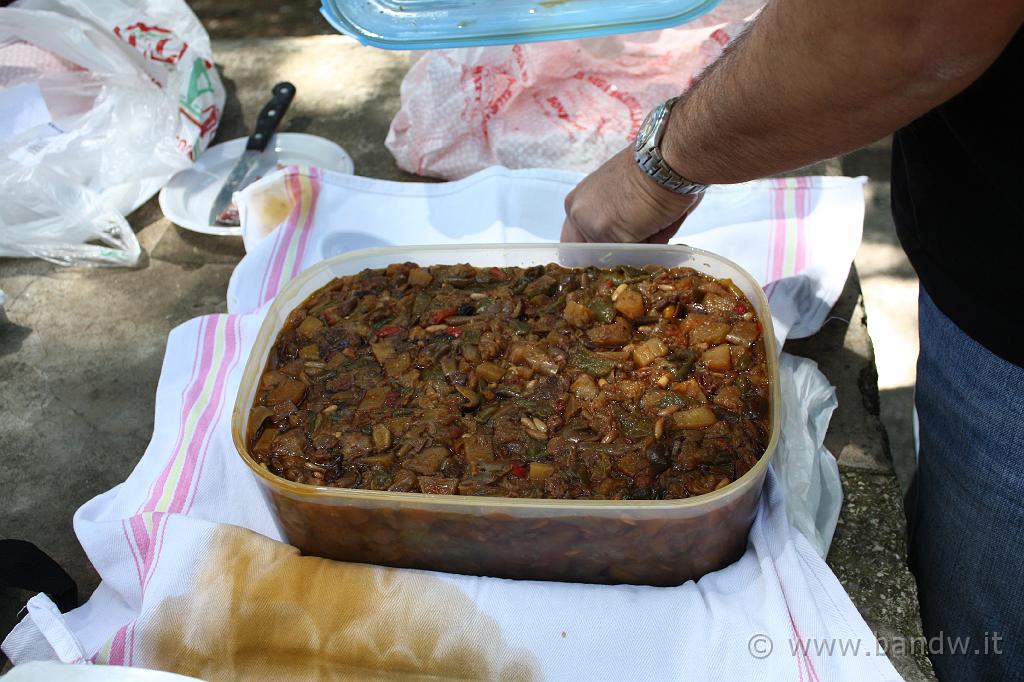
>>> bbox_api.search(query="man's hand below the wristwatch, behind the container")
[562,147,700,244]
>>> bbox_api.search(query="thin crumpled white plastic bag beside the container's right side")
[774,353,843,558]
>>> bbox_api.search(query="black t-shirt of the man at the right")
[892,30,1024,367]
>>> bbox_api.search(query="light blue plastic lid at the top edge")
[321,0,719,50]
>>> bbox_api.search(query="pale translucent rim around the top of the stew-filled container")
[231,242,781,511]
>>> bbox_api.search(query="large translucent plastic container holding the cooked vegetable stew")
[231,244,779,586]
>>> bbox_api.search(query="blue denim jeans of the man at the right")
[907,288,1024,681]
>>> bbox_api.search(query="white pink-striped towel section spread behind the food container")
[227,166,864,347]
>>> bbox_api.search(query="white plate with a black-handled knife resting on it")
[160,133,355,235]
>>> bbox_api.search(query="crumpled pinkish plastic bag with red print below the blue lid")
[386,0,763,179]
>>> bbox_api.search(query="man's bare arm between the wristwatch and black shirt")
[663,0,1024,183]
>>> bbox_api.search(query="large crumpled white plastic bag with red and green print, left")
[0,0,224,265]
